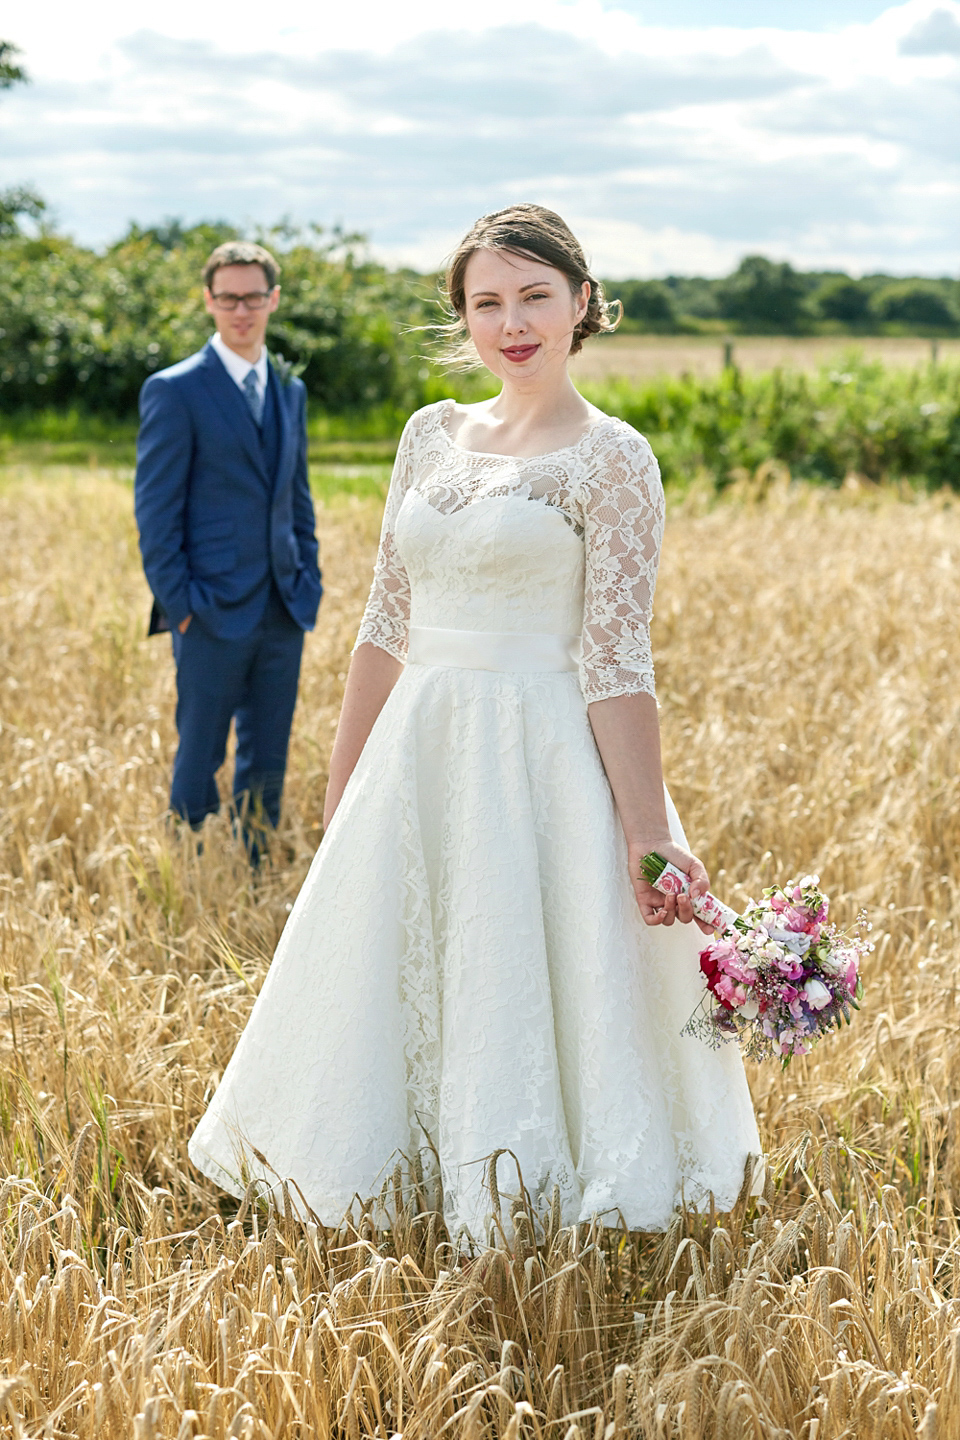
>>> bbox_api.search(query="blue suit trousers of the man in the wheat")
[170,585,304,850]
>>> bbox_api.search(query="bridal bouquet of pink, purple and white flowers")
[642,854,872,1066]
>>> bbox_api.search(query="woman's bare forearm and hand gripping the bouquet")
[587,694,710,929]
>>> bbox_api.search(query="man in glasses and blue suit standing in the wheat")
[135,240,321,840]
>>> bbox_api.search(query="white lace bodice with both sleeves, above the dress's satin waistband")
[357,400,664,703]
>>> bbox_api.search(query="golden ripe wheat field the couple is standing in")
[0,468,960,1440]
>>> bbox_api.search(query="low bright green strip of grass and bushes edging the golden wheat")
[4,354,960,490]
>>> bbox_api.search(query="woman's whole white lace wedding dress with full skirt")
[190,402,760,1237]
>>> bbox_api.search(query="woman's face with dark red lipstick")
[463,251,590,380]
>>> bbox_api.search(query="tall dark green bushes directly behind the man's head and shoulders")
[0,225,430,416]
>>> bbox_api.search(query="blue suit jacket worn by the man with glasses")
[134,344,322,639]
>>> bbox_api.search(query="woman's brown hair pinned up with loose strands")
[438,203,622,370]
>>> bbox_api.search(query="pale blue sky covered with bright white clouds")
[0,0,960,278]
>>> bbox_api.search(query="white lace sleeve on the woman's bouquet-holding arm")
[580,425,664,703]
